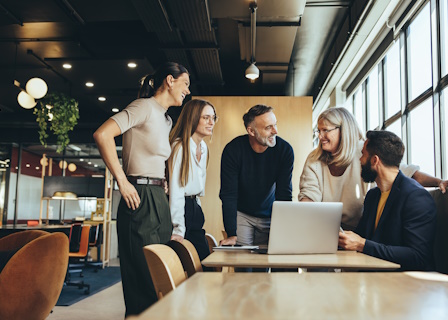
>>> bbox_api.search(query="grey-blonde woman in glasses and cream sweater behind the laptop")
[299,108,447,230]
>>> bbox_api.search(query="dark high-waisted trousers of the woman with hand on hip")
[117,185,172,316]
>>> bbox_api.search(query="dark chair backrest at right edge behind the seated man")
[429,189,448,274]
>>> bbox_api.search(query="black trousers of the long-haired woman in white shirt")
[185,198,210,261]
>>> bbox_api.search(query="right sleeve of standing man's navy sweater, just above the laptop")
[275,144,294,201]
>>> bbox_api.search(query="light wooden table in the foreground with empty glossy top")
[130,272,448,320]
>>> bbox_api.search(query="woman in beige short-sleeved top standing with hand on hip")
[93,62,190,316]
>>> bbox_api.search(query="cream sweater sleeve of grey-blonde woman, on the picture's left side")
[299,155,323,202]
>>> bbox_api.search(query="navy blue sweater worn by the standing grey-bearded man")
[219,135,294,237]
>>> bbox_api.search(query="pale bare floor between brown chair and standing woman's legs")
[47,259,125,320]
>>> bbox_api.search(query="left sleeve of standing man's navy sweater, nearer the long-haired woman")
[219,144,239,237]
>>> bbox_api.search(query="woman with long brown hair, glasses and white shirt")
[168,99,218,260]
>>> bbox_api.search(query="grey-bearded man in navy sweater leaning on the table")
[219,105,294,245]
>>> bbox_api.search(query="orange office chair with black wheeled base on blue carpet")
[65,225,90,294]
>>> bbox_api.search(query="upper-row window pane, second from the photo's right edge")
[407,3,432,101]
